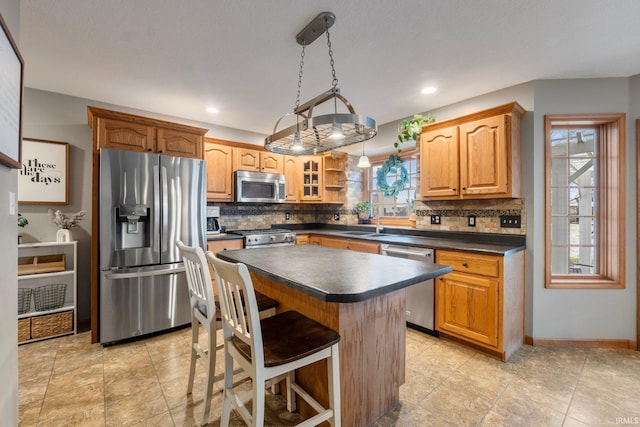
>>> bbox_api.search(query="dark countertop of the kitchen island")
[217,245,452,303]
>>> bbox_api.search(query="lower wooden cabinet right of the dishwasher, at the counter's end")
[435,250,524,360]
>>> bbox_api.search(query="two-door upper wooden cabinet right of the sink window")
[420,102,524,199]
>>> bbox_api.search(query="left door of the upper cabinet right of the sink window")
[420,126,460,198]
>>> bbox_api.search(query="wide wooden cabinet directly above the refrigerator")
[87,107,207,159]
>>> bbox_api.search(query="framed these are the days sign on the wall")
[18,138,69,205]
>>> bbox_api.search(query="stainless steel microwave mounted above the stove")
[234,171,287,203]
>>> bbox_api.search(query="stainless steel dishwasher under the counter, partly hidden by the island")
[380,243,440,337]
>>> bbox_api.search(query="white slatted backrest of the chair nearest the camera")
[206,252,264,366]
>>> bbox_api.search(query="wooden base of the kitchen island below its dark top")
[251,272,405,426]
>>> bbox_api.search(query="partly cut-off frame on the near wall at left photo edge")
[0,15,24,169]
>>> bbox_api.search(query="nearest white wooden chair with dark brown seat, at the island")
[207,252,340,427]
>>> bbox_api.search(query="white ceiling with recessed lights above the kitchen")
[19,0,640,139]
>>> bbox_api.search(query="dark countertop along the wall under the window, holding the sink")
[291,226,526,255]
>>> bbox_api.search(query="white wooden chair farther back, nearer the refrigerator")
[176,241,278,424]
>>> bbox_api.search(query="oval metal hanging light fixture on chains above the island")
[264,12,378,155]
